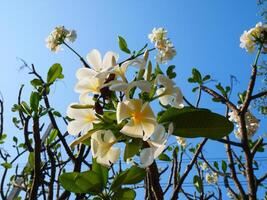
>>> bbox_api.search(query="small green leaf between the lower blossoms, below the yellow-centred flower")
[124,138,143,161]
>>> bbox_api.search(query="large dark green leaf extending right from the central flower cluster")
[159,107,234,139]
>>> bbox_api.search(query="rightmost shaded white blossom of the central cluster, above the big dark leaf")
[156,74,184,108]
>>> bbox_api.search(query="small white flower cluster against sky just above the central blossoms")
[148,28,176,63]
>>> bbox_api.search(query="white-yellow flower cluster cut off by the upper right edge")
[240,22,267,53]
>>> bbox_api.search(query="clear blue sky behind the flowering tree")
[0,0,266,198]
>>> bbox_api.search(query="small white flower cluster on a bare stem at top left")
[46,26,77,52]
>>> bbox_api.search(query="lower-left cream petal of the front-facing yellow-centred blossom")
[120,120,143,138]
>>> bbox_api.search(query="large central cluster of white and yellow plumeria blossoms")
[62,27,183,168]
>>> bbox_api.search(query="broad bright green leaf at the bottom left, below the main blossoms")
[59,171,103,195]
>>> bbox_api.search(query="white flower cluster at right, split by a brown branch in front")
[229,108,260,139]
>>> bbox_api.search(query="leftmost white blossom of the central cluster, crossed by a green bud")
[67,95,99,136]
